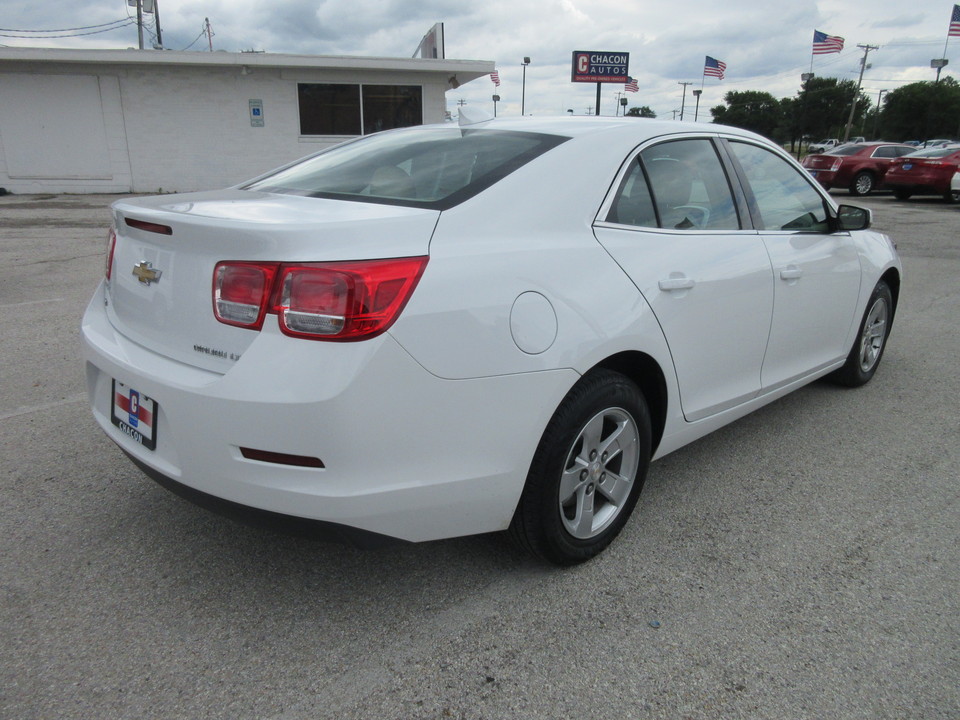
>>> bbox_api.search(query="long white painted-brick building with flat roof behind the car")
[0,48,494,193]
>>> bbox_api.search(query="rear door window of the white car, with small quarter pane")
[607,138,741,230]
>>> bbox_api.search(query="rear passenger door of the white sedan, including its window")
[594,137,773,421]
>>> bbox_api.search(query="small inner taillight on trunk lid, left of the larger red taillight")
[213,263,277,330]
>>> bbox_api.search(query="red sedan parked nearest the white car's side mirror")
[803,143,916,195]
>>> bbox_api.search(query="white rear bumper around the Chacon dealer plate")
[82,287,578,541]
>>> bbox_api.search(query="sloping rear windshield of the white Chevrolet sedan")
[244,127,569,210]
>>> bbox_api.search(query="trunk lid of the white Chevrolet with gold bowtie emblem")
[107,190,439,372]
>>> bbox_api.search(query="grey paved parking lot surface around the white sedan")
[0,188,960,720]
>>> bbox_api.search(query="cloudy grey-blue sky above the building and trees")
[0,0,960,121]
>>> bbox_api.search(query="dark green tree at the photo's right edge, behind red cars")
[880,76,960,140]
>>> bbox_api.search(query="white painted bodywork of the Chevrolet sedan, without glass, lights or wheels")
[82,118,900,541]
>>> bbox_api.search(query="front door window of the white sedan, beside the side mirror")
[730,141,830,233]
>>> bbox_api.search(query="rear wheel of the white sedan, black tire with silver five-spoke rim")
[509,370,651,565]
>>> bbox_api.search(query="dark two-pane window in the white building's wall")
[297,83,423,135]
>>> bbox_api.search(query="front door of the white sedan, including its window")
[728,140,860,391]
